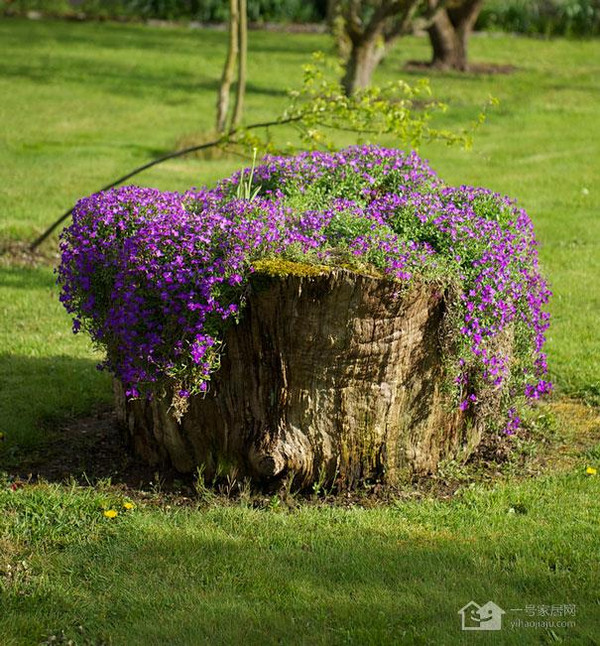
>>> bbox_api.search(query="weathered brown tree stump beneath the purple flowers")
[115,263,481,487]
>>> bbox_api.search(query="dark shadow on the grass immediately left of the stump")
[0,354,177,488]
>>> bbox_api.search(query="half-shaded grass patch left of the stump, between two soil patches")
[0,267,111,450]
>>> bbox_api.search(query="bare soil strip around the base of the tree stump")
[2,400,600,507]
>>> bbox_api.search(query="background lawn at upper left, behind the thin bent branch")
[0,19,326,238]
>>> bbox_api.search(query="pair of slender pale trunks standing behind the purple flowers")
[216,0,248,132]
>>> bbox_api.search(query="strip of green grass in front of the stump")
[0,470,600,646]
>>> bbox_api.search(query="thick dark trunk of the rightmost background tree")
[427,0,484,71]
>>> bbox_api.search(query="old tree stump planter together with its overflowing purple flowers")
[58,146,551,487]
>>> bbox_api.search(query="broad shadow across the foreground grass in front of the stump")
[7,508,596,645]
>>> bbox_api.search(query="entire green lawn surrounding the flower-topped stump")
[0,19,600,646]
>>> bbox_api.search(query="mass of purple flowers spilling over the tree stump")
[58,146,550,432]
